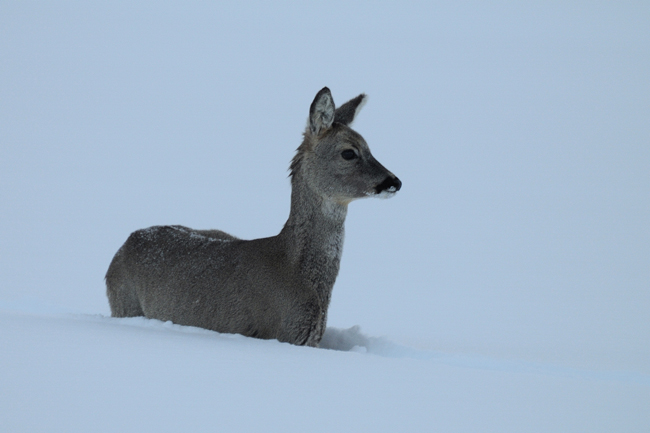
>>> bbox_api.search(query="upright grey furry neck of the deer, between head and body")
[280,179,347,311]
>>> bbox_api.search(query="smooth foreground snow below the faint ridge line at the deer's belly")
[0,300,650,432]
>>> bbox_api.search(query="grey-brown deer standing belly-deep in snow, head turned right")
[105,87,402,347]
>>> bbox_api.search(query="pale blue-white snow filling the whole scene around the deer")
[0,1,650,432]
